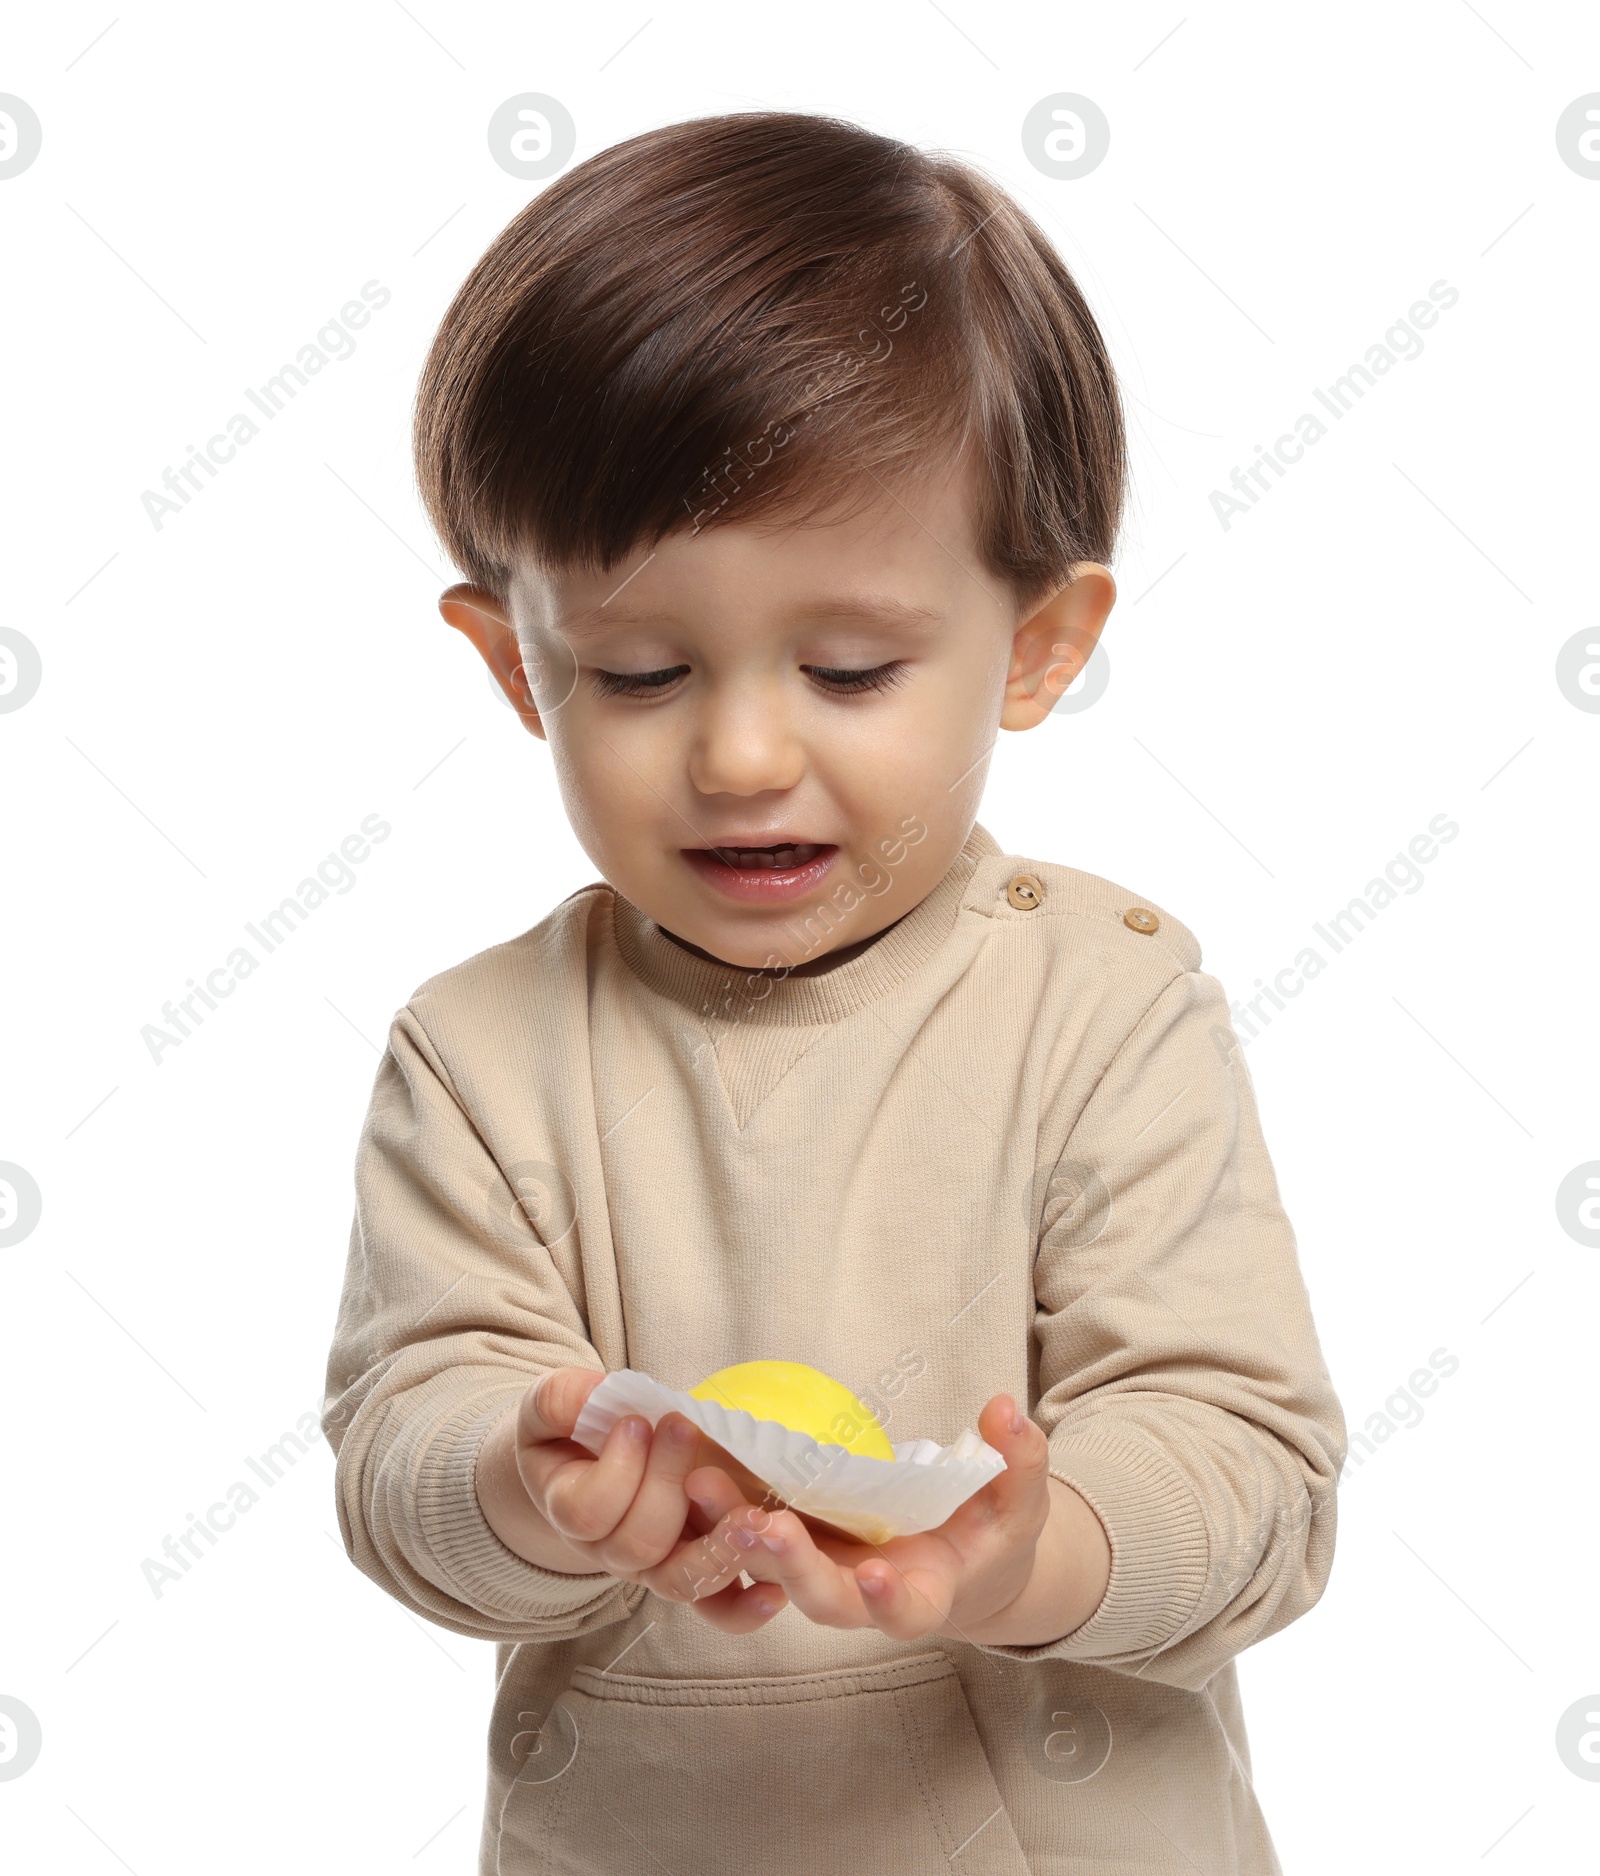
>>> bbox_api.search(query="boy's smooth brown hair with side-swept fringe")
[415,111,1125,600]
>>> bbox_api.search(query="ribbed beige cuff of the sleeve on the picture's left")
[415,1384,626,1632]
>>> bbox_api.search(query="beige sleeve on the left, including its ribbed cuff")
[323,1009,643,1642]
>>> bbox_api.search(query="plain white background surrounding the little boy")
[0,0,1600,1876]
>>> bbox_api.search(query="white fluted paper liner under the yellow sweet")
[572,1368,1005,1544]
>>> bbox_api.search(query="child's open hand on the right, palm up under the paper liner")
[687,1394,1110,1645]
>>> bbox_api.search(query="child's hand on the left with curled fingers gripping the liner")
[476,1368,786,1634]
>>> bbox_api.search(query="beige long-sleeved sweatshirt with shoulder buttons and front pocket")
[325,827,1345,1876]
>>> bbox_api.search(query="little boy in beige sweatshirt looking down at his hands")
[325,113,1343,1876]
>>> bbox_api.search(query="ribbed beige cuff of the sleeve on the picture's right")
[985,1430,1210,1660]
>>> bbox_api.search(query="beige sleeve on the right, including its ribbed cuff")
[992,970,1345,1688]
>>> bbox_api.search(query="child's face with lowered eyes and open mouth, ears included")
[441,452,1114,966]
